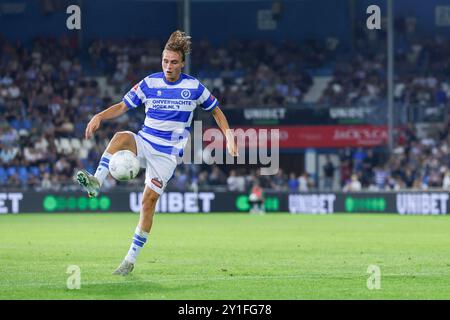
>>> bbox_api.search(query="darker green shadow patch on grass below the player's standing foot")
[76,275,198,299]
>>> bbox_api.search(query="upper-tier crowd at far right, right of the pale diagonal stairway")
[319,36,450,107]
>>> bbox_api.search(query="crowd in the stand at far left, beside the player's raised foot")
[0,38,129,190]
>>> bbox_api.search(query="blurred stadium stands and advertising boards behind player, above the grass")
[0,0,450,214]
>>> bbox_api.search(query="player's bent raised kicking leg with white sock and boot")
[75,131,137,197]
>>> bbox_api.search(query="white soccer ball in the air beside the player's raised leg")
[109,150,141,181]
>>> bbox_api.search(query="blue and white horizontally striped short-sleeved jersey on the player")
[123,72,218,156]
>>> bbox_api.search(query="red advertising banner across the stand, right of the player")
[206,125,388,149]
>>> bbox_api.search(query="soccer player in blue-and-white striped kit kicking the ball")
[76,31,238,275]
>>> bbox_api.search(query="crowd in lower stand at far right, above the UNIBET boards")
[340,121,450,191]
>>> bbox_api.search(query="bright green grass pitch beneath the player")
[0,214,450,299]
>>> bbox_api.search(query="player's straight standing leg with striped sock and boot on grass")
[113,186,159,276]
